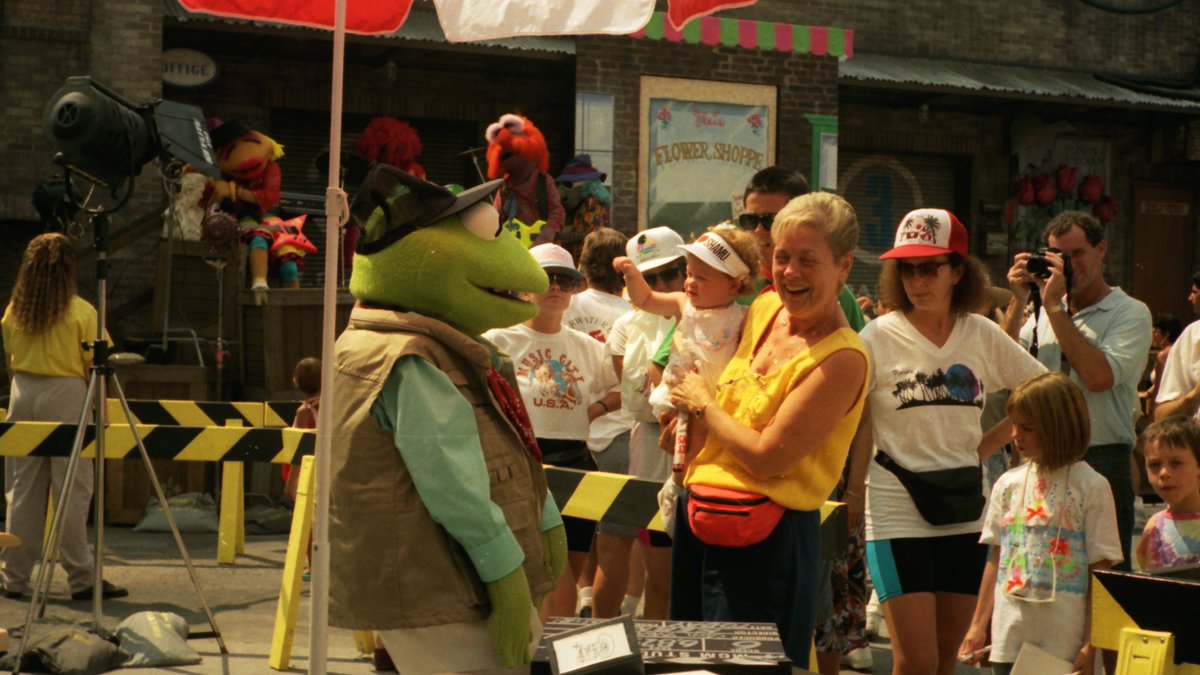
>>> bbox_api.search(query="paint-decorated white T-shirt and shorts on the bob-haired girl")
[979,461,1122,663]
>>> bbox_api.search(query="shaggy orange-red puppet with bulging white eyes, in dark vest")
[487,114,566,246]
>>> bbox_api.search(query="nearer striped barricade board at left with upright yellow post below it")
[0,415,316,563]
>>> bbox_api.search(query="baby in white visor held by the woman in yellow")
[612,225,758,466]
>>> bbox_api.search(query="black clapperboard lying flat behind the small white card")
[530,617,792,675]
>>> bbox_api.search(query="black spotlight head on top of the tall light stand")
[42,77,221,186]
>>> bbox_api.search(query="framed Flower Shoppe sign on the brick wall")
[638,77,775,237]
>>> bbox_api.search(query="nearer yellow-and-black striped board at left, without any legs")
[0,422,317,464]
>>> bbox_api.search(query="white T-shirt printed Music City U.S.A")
[484,325,618,441]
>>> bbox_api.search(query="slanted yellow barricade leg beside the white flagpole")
[268,455,314,670]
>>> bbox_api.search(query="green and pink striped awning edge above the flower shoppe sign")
[629,12,854,59]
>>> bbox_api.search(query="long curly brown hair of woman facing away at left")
[8,232,76,335]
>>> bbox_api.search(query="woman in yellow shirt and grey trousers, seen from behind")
[0,233,128,599]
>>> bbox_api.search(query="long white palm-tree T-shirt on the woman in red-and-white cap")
[859,311,1045,542]
